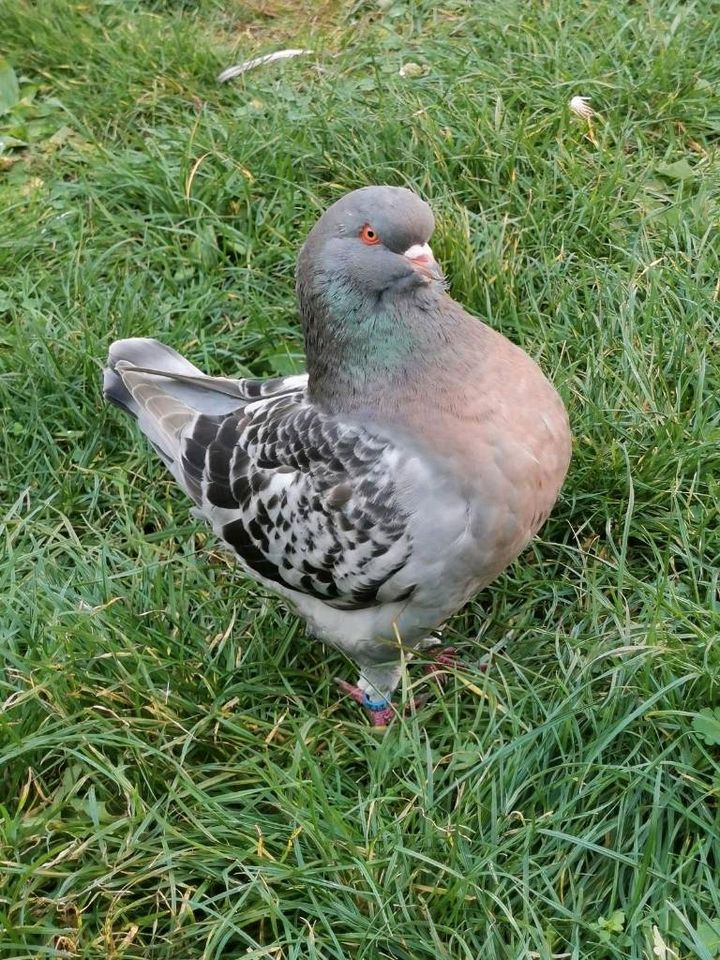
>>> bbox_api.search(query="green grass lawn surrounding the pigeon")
[0,0,720,960]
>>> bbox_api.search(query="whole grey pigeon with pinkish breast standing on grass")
[104,186,571,727]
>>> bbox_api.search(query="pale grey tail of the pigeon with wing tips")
[103,337,248,473]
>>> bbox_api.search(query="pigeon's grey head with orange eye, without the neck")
[297,187,442,298]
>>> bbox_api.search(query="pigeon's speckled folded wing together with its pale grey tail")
[105,341,414,609]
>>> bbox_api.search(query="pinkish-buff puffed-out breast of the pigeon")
[402,335,571,595]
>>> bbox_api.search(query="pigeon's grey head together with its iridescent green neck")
[297,187,452,410]
